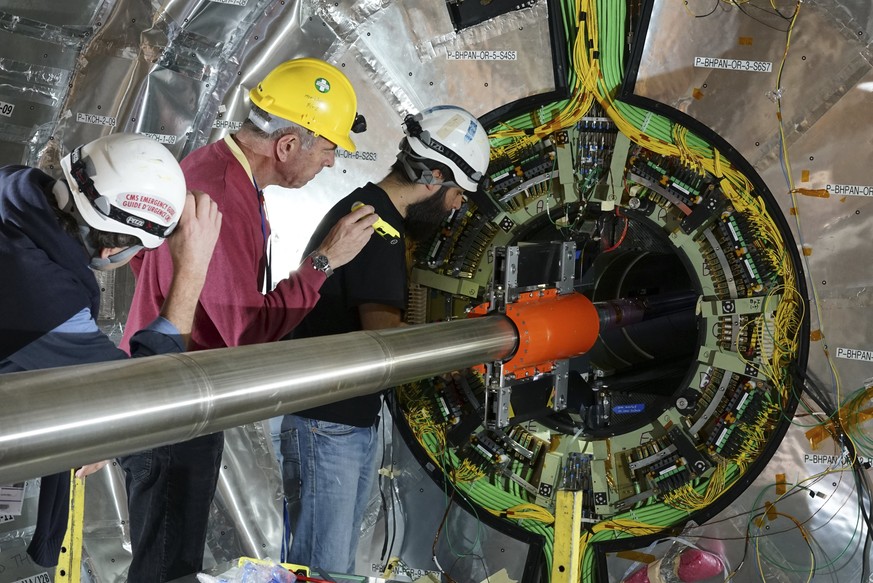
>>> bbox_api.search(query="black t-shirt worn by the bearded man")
[293,183,406,427]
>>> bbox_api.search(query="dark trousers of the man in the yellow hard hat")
[118,432,224,583]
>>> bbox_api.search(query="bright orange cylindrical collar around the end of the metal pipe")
[503,289,600,373]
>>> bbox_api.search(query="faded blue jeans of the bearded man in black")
[282,415,377,574]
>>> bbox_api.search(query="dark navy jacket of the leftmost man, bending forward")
[0,166,184,567]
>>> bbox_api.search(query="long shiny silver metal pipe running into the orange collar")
[0,315,518,484]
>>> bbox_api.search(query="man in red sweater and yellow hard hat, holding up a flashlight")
[119,58,378,583]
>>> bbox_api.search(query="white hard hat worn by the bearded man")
[401,105,491,192]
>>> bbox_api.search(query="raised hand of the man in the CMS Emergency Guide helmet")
[167,190,221,278]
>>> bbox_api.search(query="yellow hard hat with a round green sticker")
[249,58,363,152]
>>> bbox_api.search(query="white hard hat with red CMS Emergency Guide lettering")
[61,133,186,248]
